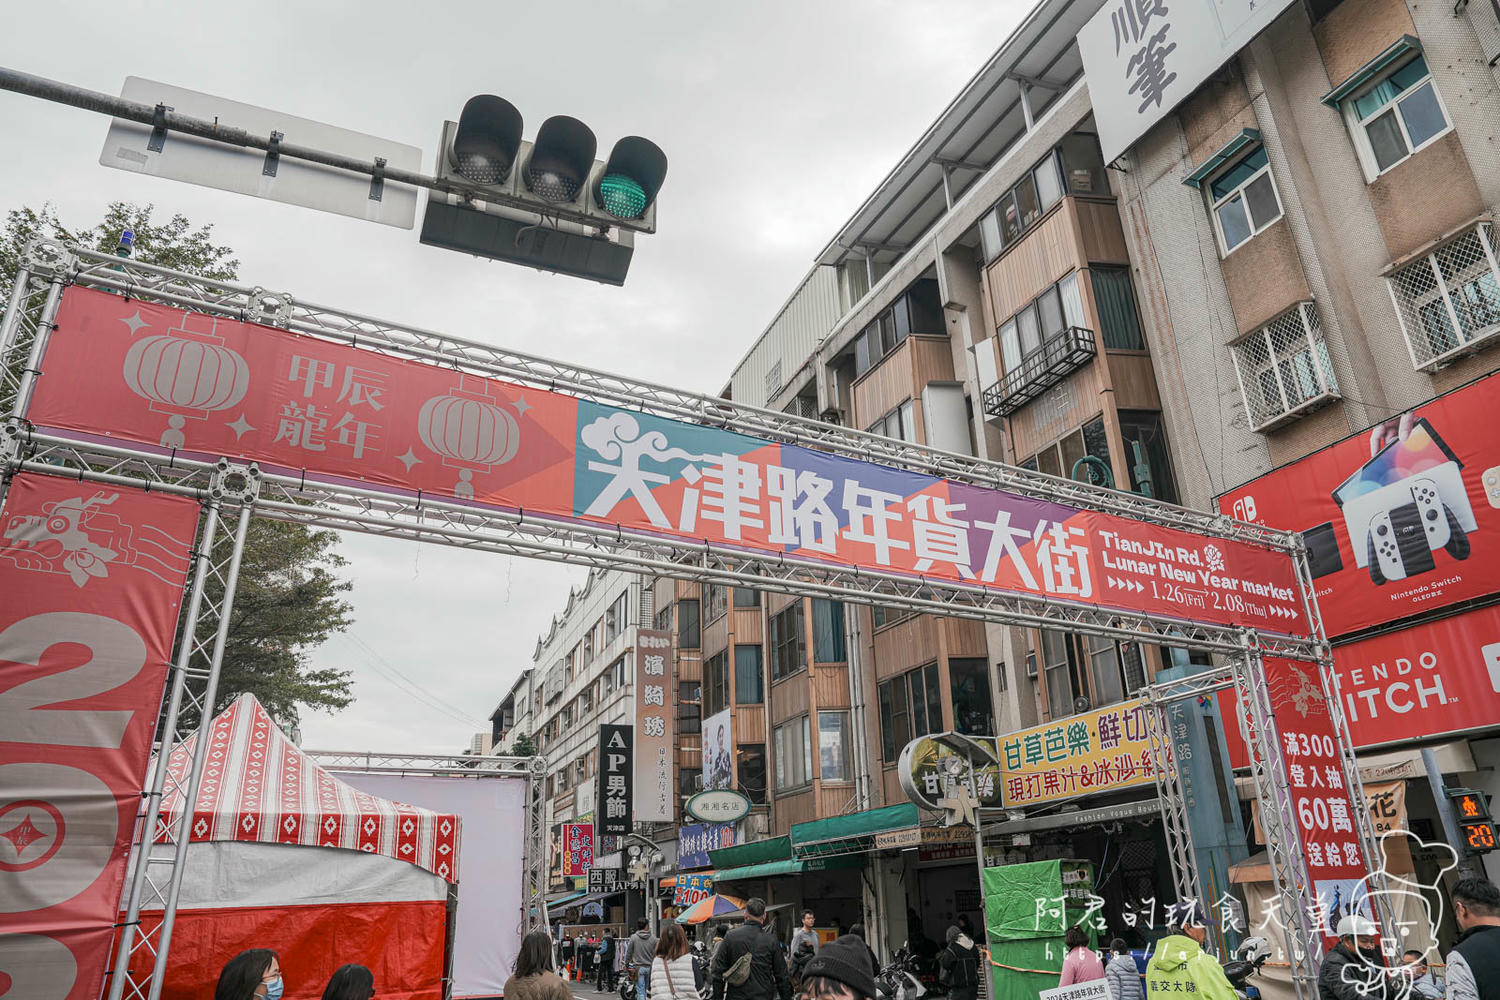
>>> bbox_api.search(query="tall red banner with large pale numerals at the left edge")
[0,474,198,1000]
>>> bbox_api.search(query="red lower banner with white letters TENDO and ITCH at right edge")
[1220,606,1500,768]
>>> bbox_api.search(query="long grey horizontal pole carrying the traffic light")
[0,66,656,232]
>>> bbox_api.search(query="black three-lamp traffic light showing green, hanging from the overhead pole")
[422,94,666,285]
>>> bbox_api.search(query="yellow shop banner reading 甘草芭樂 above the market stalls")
[999,699,1155,808]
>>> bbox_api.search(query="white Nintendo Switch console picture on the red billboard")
[1334,420,1479,585]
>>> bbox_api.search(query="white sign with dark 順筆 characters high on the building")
[1079,0,1292,163]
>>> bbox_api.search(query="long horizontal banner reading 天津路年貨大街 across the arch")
[27,286,1307,641]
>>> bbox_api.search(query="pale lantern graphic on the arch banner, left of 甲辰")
[123,313,251,448]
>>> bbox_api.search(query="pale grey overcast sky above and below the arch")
[0,0,1031,753]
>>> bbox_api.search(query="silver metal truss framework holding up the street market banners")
[0,240,1338,1000]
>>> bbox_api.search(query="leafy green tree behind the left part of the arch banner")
[0,201,354,729]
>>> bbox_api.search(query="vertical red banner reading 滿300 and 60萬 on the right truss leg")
[1265,658,1374,951]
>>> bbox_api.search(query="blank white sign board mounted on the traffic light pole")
[99,76,422,229]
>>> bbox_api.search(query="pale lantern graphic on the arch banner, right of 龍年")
[417,375,527,499]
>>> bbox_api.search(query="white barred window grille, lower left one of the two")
[1233,301,1338,430]
